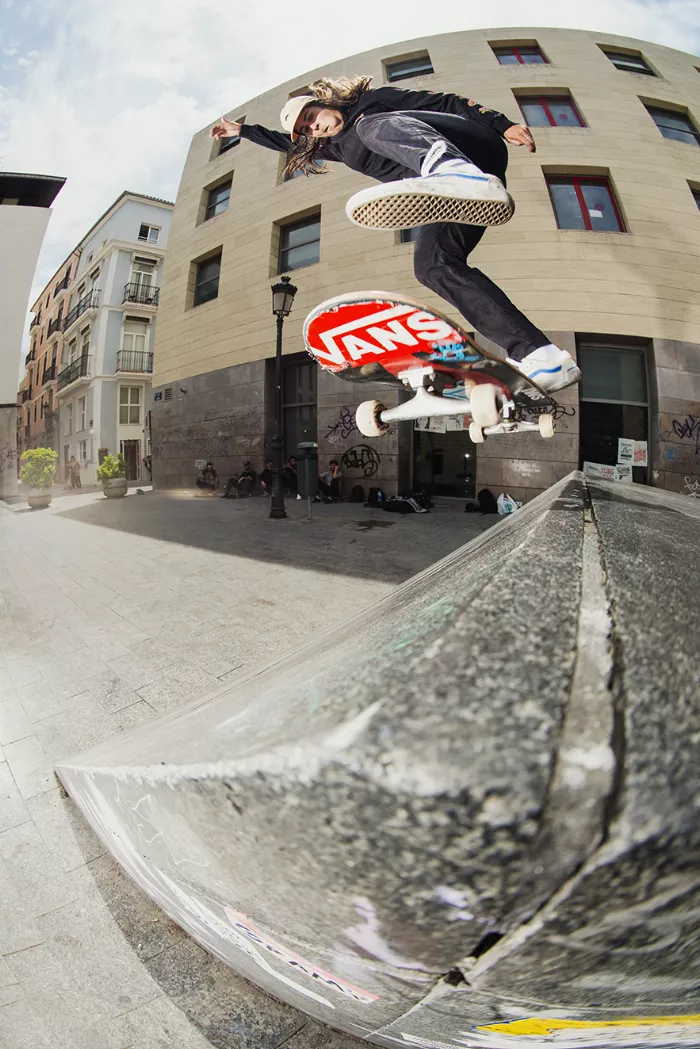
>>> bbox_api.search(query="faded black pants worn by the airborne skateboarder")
[356,112,549,361]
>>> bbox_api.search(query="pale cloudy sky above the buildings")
[0,0,700,352]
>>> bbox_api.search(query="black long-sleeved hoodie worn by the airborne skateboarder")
[240,87,514,183]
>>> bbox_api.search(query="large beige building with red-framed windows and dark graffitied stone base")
[152,28,700,499]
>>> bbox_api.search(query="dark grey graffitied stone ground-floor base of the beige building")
[151,331,700,502]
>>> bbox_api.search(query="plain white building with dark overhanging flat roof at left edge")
[0,172,65,498]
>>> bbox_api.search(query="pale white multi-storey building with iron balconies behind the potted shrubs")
[57,191,173,485]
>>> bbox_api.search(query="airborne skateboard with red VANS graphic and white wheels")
[303,292,556,444]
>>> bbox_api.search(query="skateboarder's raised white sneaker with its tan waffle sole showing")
[345,159,514,230]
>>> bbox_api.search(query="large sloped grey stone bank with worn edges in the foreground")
[58,475,700,1047]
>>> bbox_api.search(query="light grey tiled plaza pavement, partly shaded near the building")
[0,491,493,1049]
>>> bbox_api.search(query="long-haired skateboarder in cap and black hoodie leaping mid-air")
[210,77,580,391]
